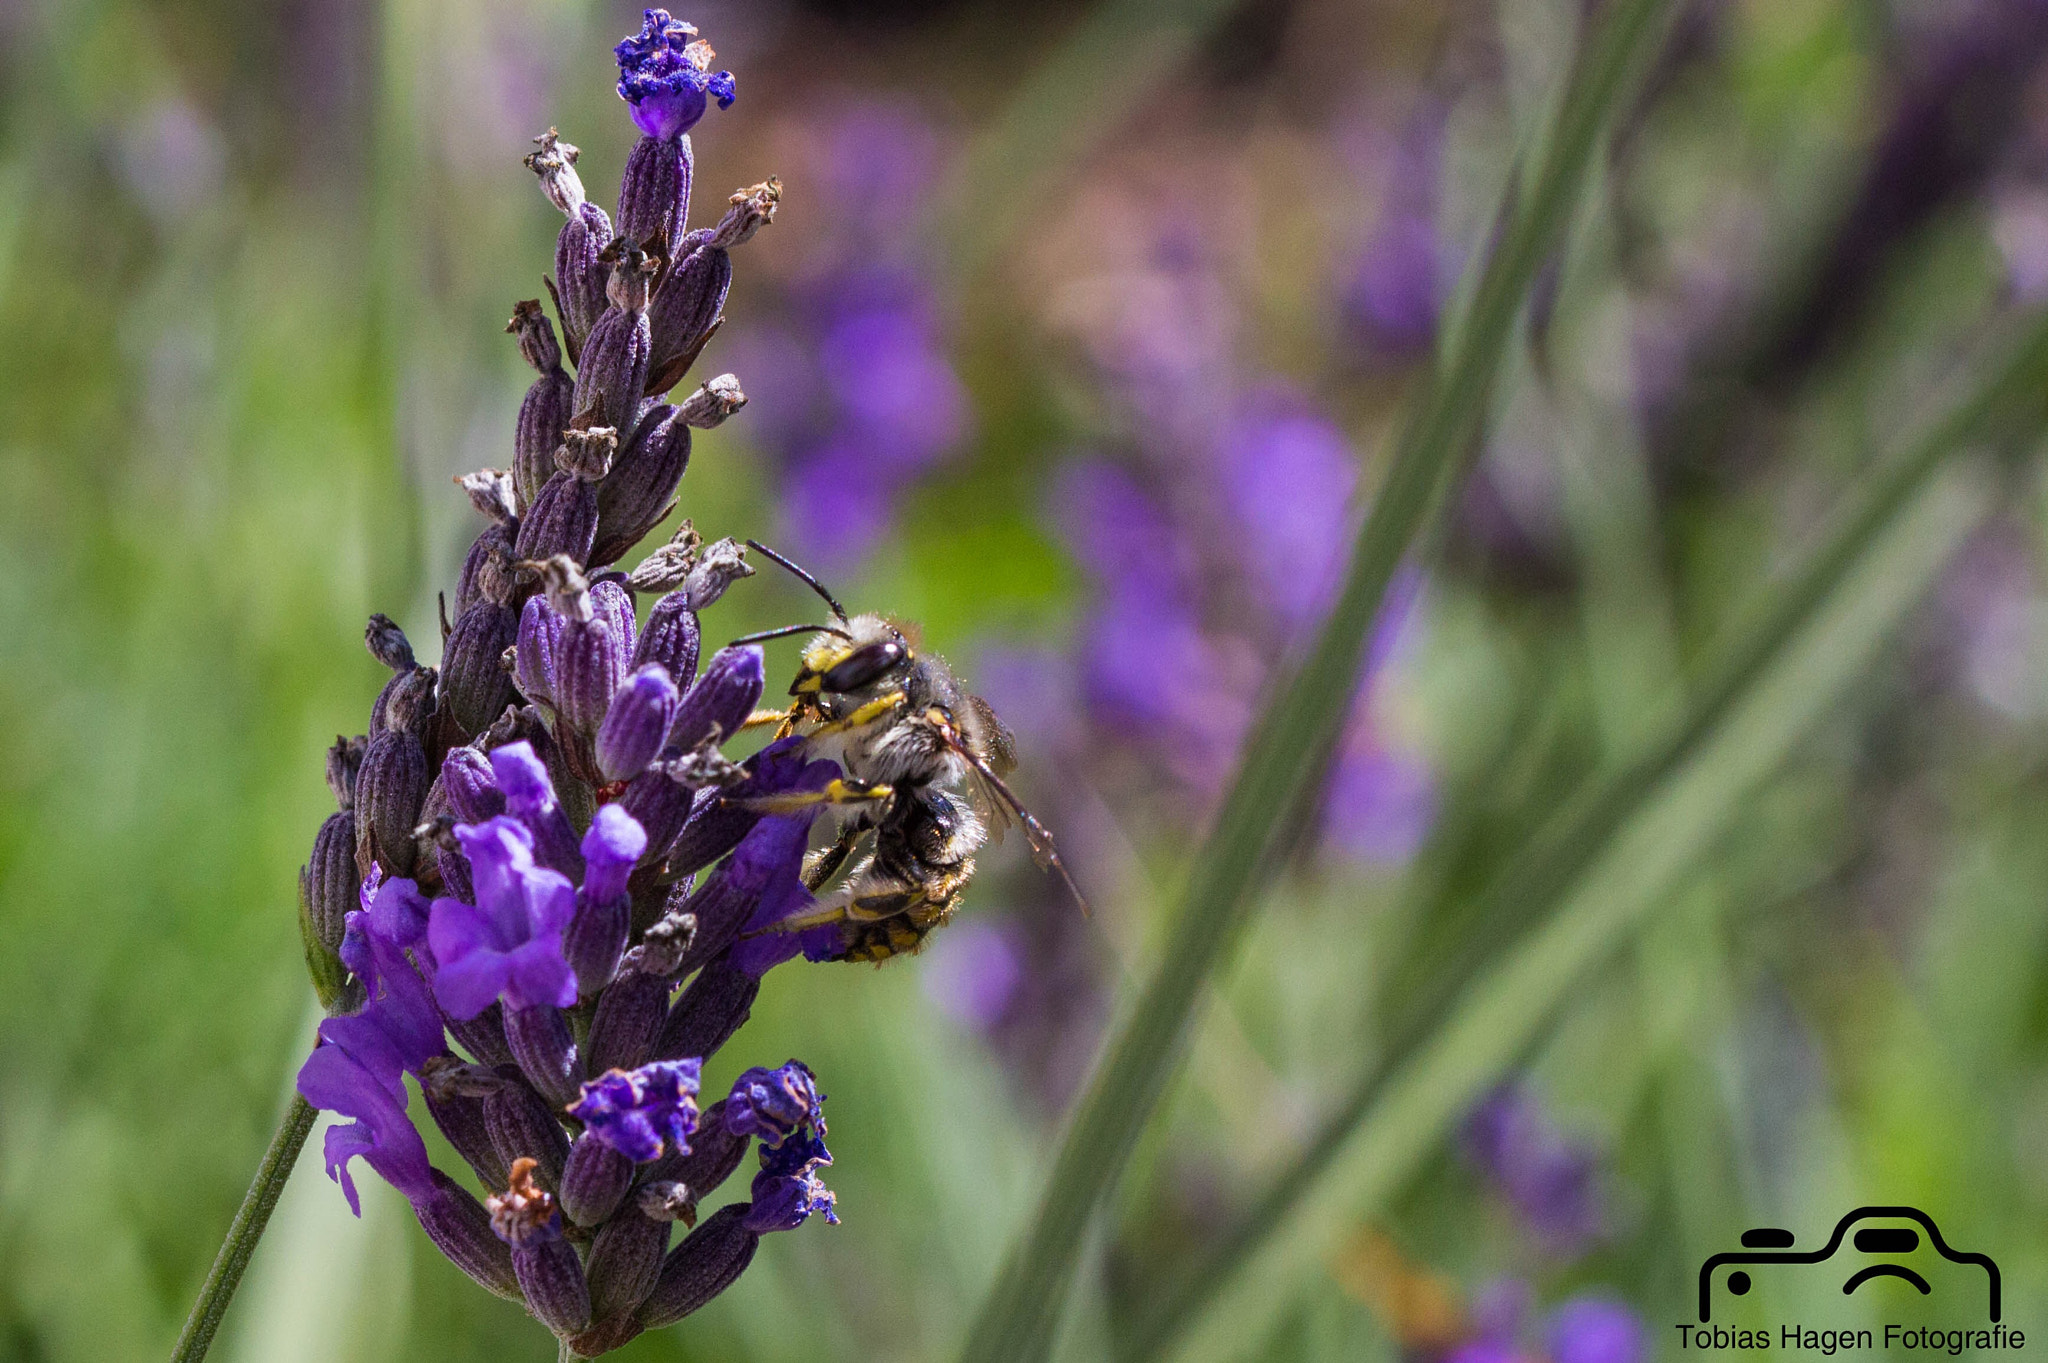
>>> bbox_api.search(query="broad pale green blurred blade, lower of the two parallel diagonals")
[1155,456,1991,1359]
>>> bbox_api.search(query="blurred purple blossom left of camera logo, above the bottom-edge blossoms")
[1464,1085,1604,1259]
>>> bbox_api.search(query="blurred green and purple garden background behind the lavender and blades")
[0,0,2048,1363]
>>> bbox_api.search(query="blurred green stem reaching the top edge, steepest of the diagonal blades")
[963,0,1673,1363]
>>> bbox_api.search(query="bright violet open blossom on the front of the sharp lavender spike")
[426,810,575,1019]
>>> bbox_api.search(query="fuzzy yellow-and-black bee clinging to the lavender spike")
[737,540,1087,962]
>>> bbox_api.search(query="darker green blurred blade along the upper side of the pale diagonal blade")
[1126,304,2048,1359]
